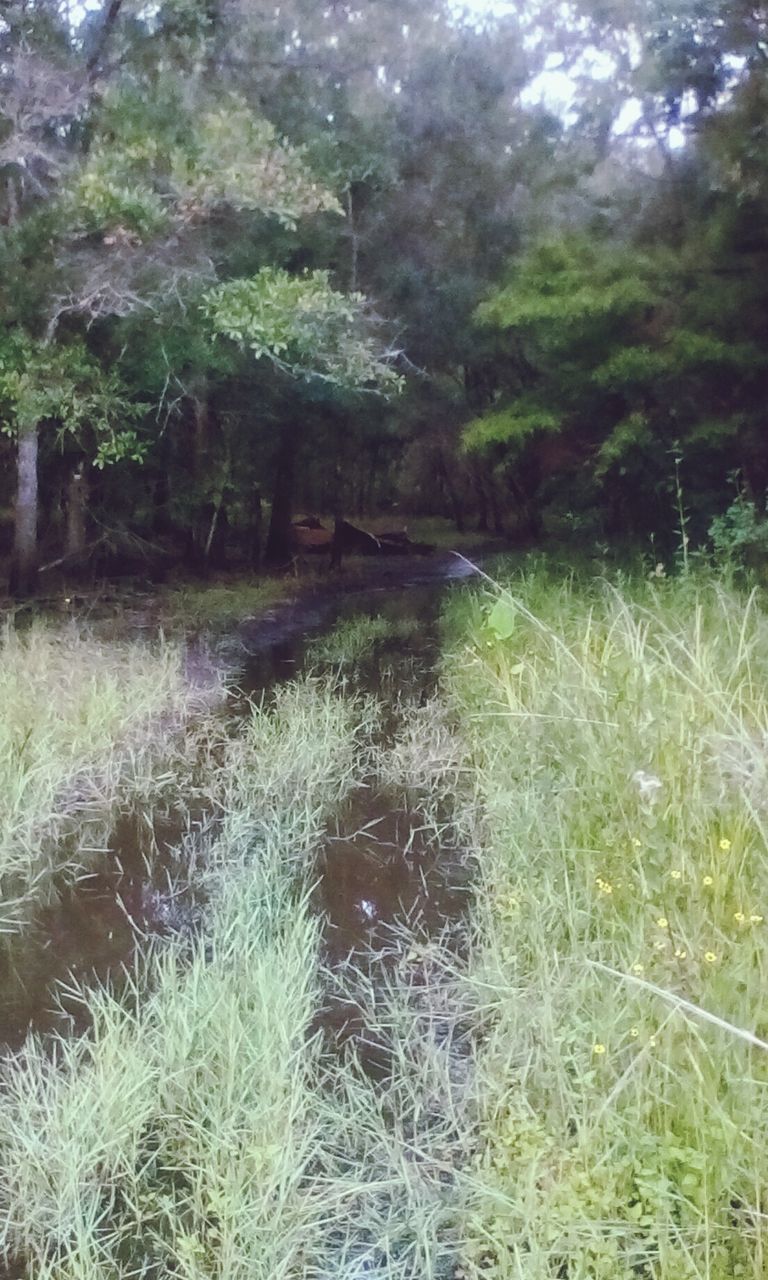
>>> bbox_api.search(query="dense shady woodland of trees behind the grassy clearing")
[0,0,768,594]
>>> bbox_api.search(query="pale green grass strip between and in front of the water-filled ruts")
[0,680,466,1280]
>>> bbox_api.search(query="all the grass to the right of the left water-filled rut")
[0,562,768,1280]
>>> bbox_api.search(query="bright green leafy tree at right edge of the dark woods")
[465,237,768,534]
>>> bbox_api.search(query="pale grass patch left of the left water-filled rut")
[0,625,209,932]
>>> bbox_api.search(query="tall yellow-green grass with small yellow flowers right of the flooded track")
[448,568,768,1280]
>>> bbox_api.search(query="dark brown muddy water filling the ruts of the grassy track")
[0,557,471,1053]
